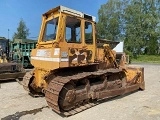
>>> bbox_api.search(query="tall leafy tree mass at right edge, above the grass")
[125,0,160,54]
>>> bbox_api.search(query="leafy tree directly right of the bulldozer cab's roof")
[97,0,119,40]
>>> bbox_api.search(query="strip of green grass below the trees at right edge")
[131,55,160,64]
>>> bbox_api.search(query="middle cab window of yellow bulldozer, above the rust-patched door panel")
[66,16,81,43]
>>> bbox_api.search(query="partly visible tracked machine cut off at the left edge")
[0,37,26,81]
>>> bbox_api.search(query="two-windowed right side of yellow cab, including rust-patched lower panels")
[61,15,95,66]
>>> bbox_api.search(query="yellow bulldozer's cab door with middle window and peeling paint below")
[61,15,86,66]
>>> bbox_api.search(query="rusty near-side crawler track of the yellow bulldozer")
[45,69,139,116]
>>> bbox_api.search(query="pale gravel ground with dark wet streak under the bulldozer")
[0,64,160,120]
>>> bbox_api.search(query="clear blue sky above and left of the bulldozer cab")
[0,0,107,39]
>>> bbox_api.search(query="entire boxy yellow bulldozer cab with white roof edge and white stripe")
[31,6,96,70]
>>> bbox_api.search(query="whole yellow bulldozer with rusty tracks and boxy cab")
[22,6,145,116]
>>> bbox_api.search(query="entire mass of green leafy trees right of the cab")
[97,0,160,55]
